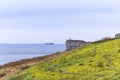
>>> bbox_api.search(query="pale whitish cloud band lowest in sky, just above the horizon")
[0,27,119,43]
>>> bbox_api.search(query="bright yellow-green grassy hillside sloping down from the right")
[10,39,120,80]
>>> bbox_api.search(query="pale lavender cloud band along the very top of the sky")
[0,0,120,14]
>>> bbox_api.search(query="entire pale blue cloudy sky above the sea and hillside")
[0,0,120,43]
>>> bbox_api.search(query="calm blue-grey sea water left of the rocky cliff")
[0,44,65,65]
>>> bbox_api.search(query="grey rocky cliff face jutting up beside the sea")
[66,40,88,50]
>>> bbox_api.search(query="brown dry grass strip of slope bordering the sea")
[0,52,64,80]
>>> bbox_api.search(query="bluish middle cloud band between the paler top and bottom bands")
[0,13,120,29]
